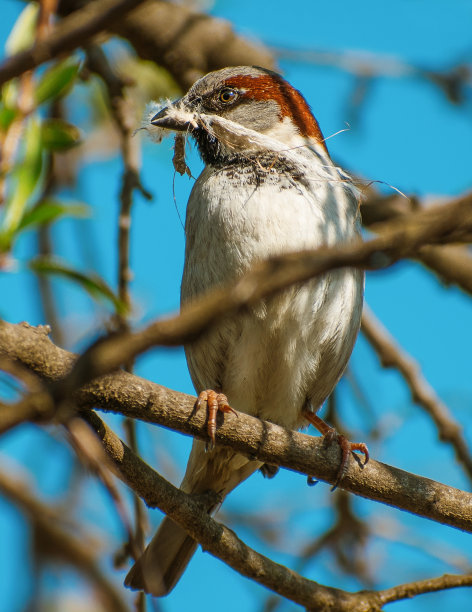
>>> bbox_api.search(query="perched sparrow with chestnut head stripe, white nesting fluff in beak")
[125,66,368,595]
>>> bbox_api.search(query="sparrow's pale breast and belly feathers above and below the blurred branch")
[182,155,362,427]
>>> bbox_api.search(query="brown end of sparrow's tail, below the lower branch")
[125,517,197,597]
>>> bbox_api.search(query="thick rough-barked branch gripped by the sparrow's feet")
[0,322,472,532]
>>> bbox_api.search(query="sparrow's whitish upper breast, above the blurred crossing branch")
[182,155,356,299]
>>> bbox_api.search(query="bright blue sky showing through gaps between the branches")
[0,0,472,612]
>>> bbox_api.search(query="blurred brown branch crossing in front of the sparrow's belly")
[55,194,472,397]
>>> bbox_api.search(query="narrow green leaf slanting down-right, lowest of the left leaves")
[28,256,127,314]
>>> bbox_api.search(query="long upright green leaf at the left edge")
[0,116,42,245]
